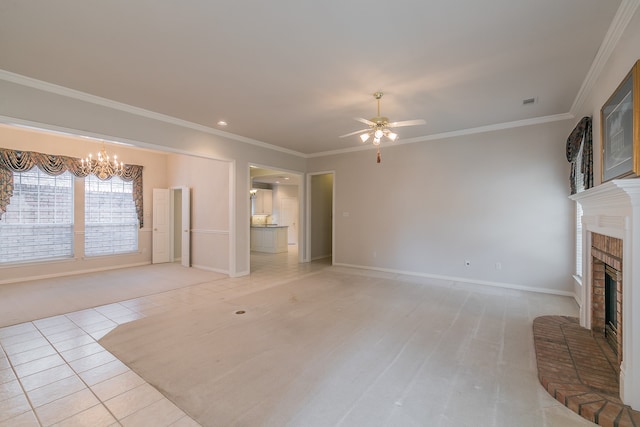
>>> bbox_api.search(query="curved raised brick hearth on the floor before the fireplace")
[533,316,640,427]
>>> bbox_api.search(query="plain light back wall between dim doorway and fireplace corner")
[309,121,573,293]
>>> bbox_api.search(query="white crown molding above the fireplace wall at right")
[569,0,640,116]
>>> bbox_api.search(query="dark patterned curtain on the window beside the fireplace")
[566,117,593,194]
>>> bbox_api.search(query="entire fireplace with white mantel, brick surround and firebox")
[571,179,640,410]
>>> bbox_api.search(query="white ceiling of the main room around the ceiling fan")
[0,0,621,154]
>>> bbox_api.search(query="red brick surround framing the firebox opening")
[591,233,624,373]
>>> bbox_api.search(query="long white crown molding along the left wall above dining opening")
[0,69,306,158]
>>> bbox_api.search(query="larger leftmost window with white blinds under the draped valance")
[0,167,73,263]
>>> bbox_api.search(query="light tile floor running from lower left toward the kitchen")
[0,246,320,427]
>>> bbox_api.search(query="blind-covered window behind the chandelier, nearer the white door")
[84,175,138,256]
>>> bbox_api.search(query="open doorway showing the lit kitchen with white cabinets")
[249,165,303,272]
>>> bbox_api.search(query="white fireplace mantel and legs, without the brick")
[571,179,640,410]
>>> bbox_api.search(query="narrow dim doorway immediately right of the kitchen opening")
[305,172,335,265]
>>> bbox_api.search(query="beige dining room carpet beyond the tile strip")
[0,263,227,327]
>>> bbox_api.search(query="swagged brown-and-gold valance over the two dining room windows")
[0,148,143,228]
